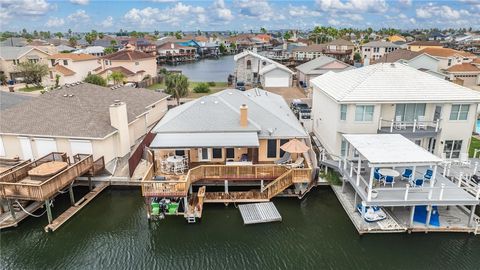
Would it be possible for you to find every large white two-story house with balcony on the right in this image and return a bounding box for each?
[311,63,480,158]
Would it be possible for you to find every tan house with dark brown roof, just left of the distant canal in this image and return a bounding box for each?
[96,49,157,82]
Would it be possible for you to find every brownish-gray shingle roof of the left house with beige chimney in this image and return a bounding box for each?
[0,83,168,138]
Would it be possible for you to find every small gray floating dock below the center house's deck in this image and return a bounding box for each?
[238,202,282,225]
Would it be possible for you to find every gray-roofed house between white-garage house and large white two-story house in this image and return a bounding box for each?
[296,56,354,87]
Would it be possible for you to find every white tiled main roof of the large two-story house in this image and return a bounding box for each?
[311,63,480,103]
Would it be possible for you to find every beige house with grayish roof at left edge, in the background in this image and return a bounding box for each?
[0,47,50,80]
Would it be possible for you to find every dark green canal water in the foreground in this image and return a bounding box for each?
[0,187,480,270]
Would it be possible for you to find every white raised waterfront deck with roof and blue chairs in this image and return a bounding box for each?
[339,134,480,233]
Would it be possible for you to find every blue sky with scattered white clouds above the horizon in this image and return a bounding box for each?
[0,0,480,32]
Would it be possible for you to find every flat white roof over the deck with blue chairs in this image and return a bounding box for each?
[343,134,442,166]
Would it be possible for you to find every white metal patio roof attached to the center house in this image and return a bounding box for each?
[150,132,260,149]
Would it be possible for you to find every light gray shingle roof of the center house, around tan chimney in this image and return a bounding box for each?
[153,88,308,138]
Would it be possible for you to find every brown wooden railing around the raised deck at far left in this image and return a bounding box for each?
[0,153,93,201]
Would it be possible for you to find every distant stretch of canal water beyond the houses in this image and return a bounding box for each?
[163,55,235,82]
